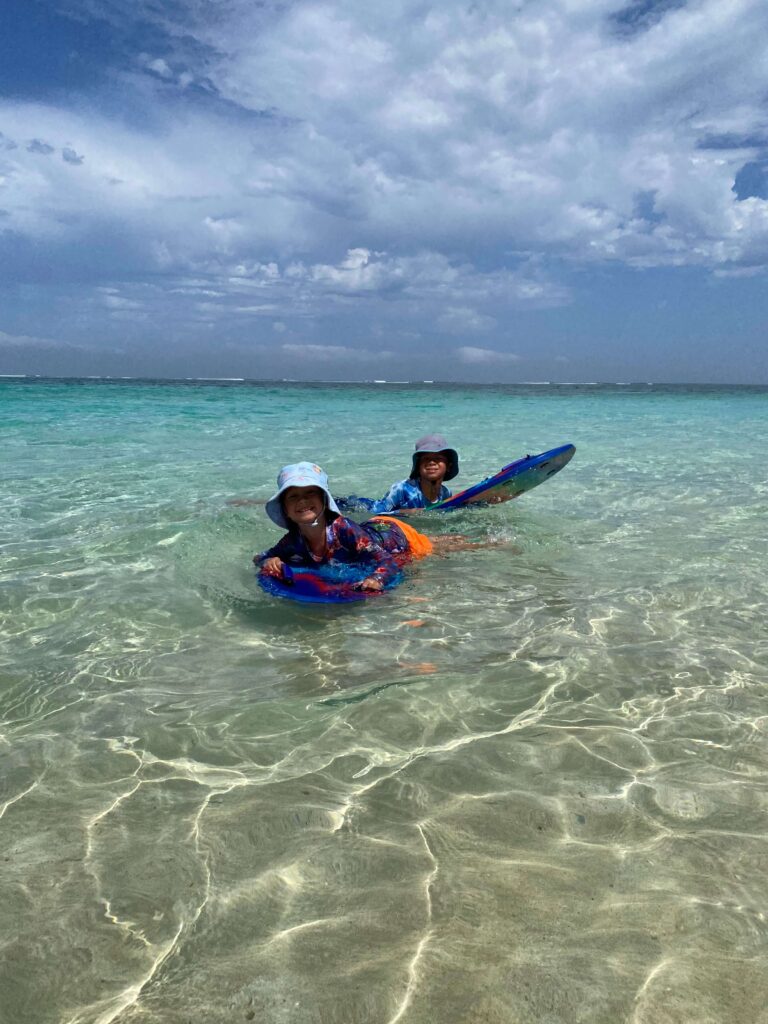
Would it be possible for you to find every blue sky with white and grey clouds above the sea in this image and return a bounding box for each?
[0,0,768,383]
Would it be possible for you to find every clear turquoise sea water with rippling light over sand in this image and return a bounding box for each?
[0,380,768,1024]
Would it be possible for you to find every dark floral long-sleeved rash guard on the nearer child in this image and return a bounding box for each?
[254,515,409,584]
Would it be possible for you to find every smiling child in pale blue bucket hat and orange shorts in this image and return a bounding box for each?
[254,462,432,590]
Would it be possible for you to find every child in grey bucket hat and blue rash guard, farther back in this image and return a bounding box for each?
[337,434,459,515]
